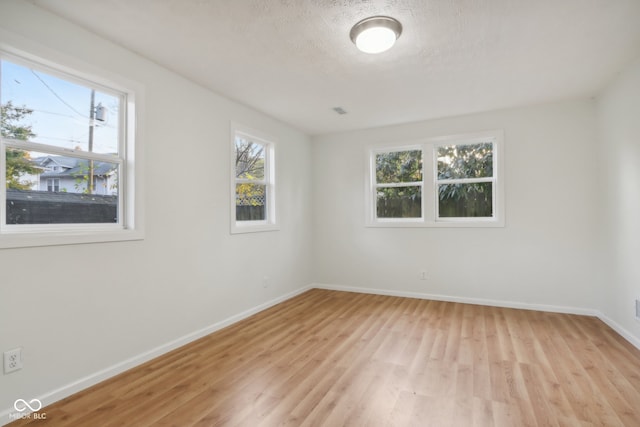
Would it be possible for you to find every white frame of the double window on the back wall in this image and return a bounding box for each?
[365,130,505,227]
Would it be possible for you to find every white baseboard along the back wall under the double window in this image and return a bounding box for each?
[312,283,598,316]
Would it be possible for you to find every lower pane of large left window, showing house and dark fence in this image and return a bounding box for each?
[5,148,119,224]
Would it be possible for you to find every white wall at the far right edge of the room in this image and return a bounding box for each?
[598,56,640,345]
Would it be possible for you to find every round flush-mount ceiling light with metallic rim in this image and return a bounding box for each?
[349,16,402,53]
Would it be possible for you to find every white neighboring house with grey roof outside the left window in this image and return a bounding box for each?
[33,156,118,195]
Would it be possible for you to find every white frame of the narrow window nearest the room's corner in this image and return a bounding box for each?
[230,122,280,234]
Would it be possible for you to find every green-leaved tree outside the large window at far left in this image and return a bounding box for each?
[0,101,39,190]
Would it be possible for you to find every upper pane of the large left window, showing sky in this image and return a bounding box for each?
[0,60,121,155]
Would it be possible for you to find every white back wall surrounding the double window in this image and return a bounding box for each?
[313,100,601,312]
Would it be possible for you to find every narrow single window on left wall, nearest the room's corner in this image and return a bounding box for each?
[231,125,277,233]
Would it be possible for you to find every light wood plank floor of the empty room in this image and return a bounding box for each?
[8,290,640,427]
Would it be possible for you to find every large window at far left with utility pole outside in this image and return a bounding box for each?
[0,47,140,247]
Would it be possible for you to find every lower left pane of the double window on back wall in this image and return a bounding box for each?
[376,186,422,218]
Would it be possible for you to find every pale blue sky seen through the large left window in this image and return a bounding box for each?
[0,60,120,153]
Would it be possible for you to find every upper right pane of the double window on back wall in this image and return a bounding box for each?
[438,142,493,179]
